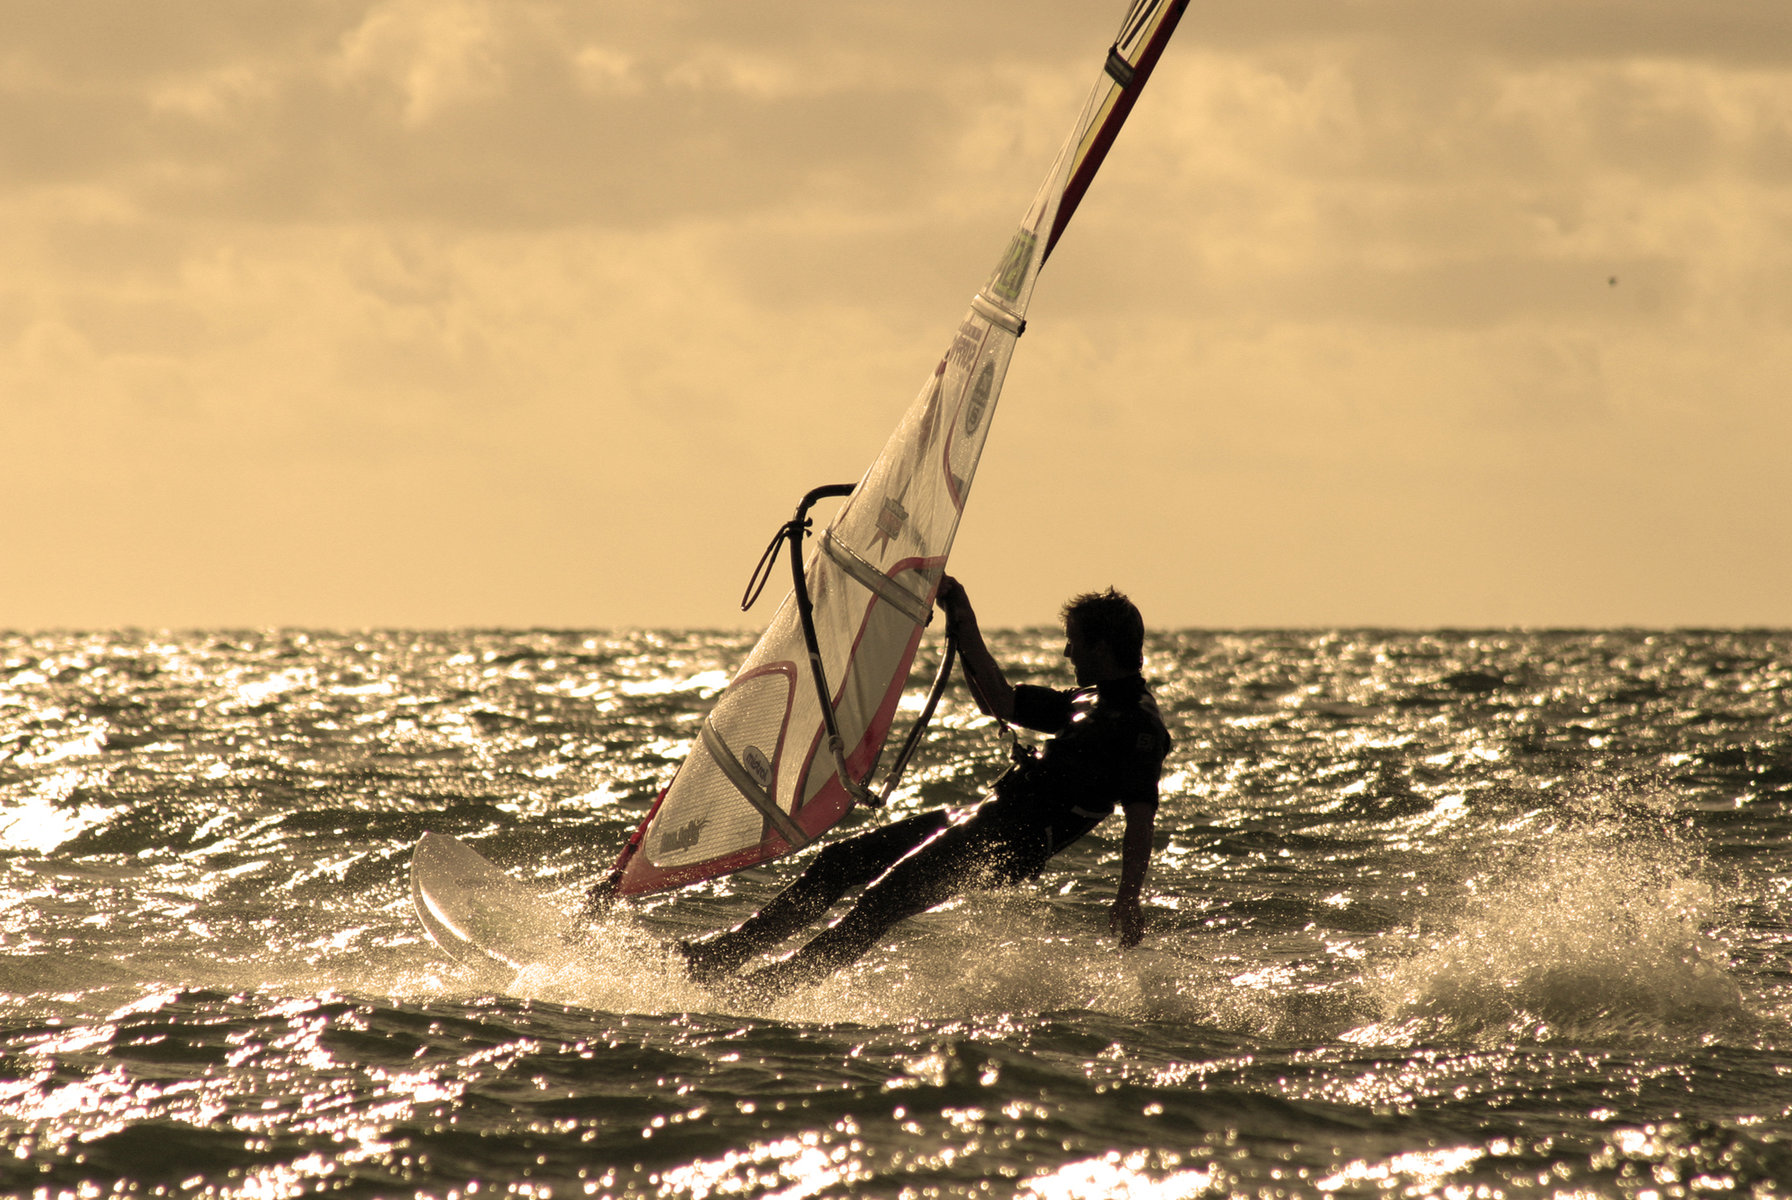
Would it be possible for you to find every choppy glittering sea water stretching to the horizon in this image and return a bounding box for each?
[0,630,1792,1200]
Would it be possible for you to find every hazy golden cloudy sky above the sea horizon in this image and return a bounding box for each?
[0,0,1792,630]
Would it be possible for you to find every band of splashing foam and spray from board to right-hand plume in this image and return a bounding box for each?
[385,813,1758,1044]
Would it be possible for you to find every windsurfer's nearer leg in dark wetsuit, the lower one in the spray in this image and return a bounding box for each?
[742,813,1052,999]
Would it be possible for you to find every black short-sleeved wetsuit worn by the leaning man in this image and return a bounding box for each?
[683,675,1170,996]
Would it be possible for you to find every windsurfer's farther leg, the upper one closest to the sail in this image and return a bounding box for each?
[679,810,946,983]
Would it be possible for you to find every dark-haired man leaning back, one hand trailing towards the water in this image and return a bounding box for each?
[681,575,1170,998]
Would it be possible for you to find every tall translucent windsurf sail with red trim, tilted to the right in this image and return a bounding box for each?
[609,0,1186,896]
